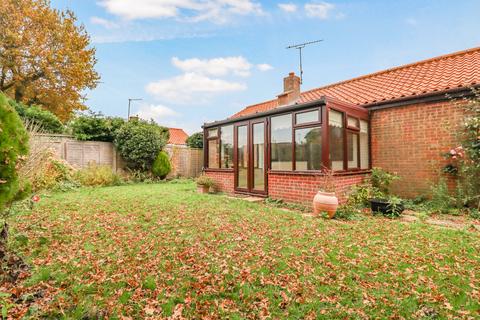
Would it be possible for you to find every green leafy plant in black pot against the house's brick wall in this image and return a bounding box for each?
[370,168,405,217]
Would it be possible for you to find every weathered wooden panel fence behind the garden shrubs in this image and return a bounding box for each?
[34,134,203,178]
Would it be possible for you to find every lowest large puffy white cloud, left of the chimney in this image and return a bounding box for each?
[146,72,247,103]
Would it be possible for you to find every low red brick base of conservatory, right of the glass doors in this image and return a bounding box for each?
[268,172,367,205]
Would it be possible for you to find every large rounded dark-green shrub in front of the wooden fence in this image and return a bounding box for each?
[114,120,169,171]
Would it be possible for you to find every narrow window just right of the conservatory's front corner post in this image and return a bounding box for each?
[328,110,344,171]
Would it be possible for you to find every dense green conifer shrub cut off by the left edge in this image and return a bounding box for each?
[0,93,28,212]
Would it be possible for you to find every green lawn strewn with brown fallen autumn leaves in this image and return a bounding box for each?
[4,182,480,319]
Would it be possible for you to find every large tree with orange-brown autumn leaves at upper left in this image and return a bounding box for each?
[0,0,99,120]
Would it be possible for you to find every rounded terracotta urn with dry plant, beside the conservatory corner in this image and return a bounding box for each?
[313,168,338,219]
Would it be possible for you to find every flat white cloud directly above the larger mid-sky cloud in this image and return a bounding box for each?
[172,56,252,77]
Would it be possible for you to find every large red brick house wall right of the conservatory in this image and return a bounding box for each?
[370,102,464,197]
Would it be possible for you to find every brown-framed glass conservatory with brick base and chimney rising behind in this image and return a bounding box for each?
[203,74,370,202]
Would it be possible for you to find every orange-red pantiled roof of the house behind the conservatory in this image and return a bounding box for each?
[232,47,480,118]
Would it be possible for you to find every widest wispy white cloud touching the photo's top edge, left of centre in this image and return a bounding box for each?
[99,0,263,23]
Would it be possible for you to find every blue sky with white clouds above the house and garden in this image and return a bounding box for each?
[52,0,480,134]
